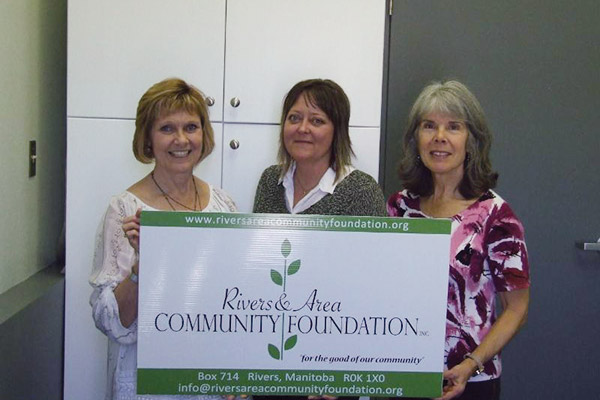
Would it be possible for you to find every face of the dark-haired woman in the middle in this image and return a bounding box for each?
[283,94,335,168]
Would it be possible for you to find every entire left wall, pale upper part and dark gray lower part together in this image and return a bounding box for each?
[0,0,67,400]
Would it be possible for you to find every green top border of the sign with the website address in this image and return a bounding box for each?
[141,211,452,235]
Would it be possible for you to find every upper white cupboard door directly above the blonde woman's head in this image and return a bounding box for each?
[67,0,225,121]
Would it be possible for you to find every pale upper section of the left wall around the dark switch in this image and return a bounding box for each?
[0,0,67,294]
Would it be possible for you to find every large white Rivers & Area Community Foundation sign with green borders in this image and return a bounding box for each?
[138,212,450,397]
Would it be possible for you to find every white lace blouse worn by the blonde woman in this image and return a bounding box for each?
[90,186,236,400]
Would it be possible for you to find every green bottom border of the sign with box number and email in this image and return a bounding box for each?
[137,368,442,398]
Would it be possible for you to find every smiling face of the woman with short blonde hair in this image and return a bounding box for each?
[150,111,202,173]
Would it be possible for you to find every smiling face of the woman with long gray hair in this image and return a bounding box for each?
[417,112,469,180]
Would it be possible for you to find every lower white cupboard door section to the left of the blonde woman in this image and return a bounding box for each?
[65,118,152,400]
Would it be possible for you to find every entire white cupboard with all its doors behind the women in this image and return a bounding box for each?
[65,0,386,399]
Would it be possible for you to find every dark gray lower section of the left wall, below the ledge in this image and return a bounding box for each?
[0,268,65,400]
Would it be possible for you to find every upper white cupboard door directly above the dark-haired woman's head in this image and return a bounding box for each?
[224,0,386,126]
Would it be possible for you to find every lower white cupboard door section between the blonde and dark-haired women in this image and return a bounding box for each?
[223,124,279,212]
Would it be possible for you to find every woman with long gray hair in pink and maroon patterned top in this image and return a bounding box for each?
[387,81,530,400]
